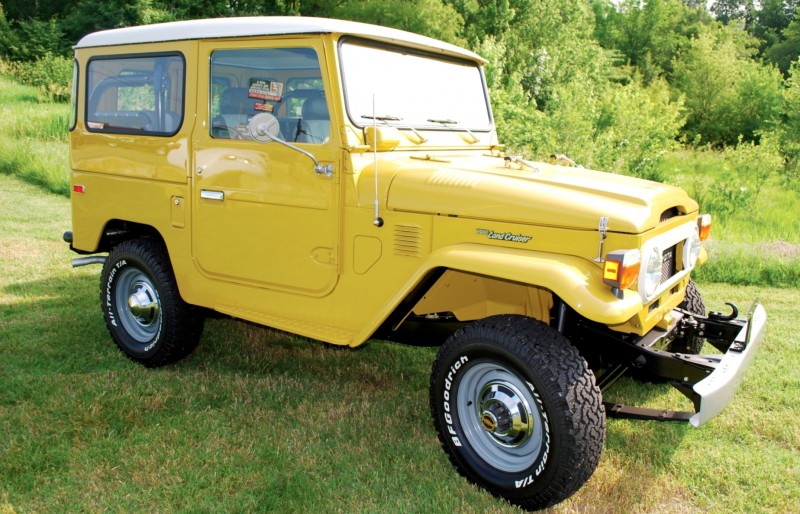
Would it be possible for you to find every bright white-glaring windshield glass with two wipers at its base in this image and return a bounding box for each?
[340,42,491,131]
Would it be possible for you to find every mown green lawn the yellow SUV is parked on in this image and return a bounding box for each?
[0,175,800,513]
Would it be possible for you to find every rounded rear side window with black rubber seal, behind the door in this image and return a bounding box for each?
[86,54,186,136]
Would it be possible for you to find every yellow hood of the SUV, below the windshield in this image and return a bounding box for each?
[373,157,698,234]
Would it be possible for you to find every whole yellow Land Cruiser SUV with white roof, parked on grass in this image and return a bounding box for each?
[64,17,766,508]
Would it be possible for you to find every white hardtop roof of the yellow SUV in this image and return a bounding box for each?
[75,16,486,63]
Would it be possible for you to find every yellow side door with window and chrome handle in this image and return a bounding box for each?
[192,39,340,296]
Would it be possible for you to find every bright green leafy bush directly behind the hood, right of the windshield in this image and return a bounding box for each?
[494,71,683,180]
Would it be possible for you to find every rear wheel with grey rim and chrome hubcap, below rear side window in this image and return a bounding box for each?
[100,239,203,367]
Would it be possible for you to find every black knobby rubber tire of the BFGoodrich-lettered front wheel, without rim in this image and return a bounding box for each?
[430,315,606,509]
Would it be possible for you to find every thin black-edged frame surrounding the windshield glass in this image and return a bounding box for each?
[337,36,494,133]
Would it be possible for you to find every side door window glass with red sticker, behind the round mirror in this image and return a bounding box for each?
[209,48,331,144]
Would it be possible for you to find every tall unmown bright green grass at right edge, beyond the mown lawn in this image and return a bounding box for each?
[660,151,800,288]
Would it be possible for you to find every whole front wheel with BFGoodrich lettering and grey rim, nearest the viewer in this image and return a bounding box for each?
[430,316,605,509]
